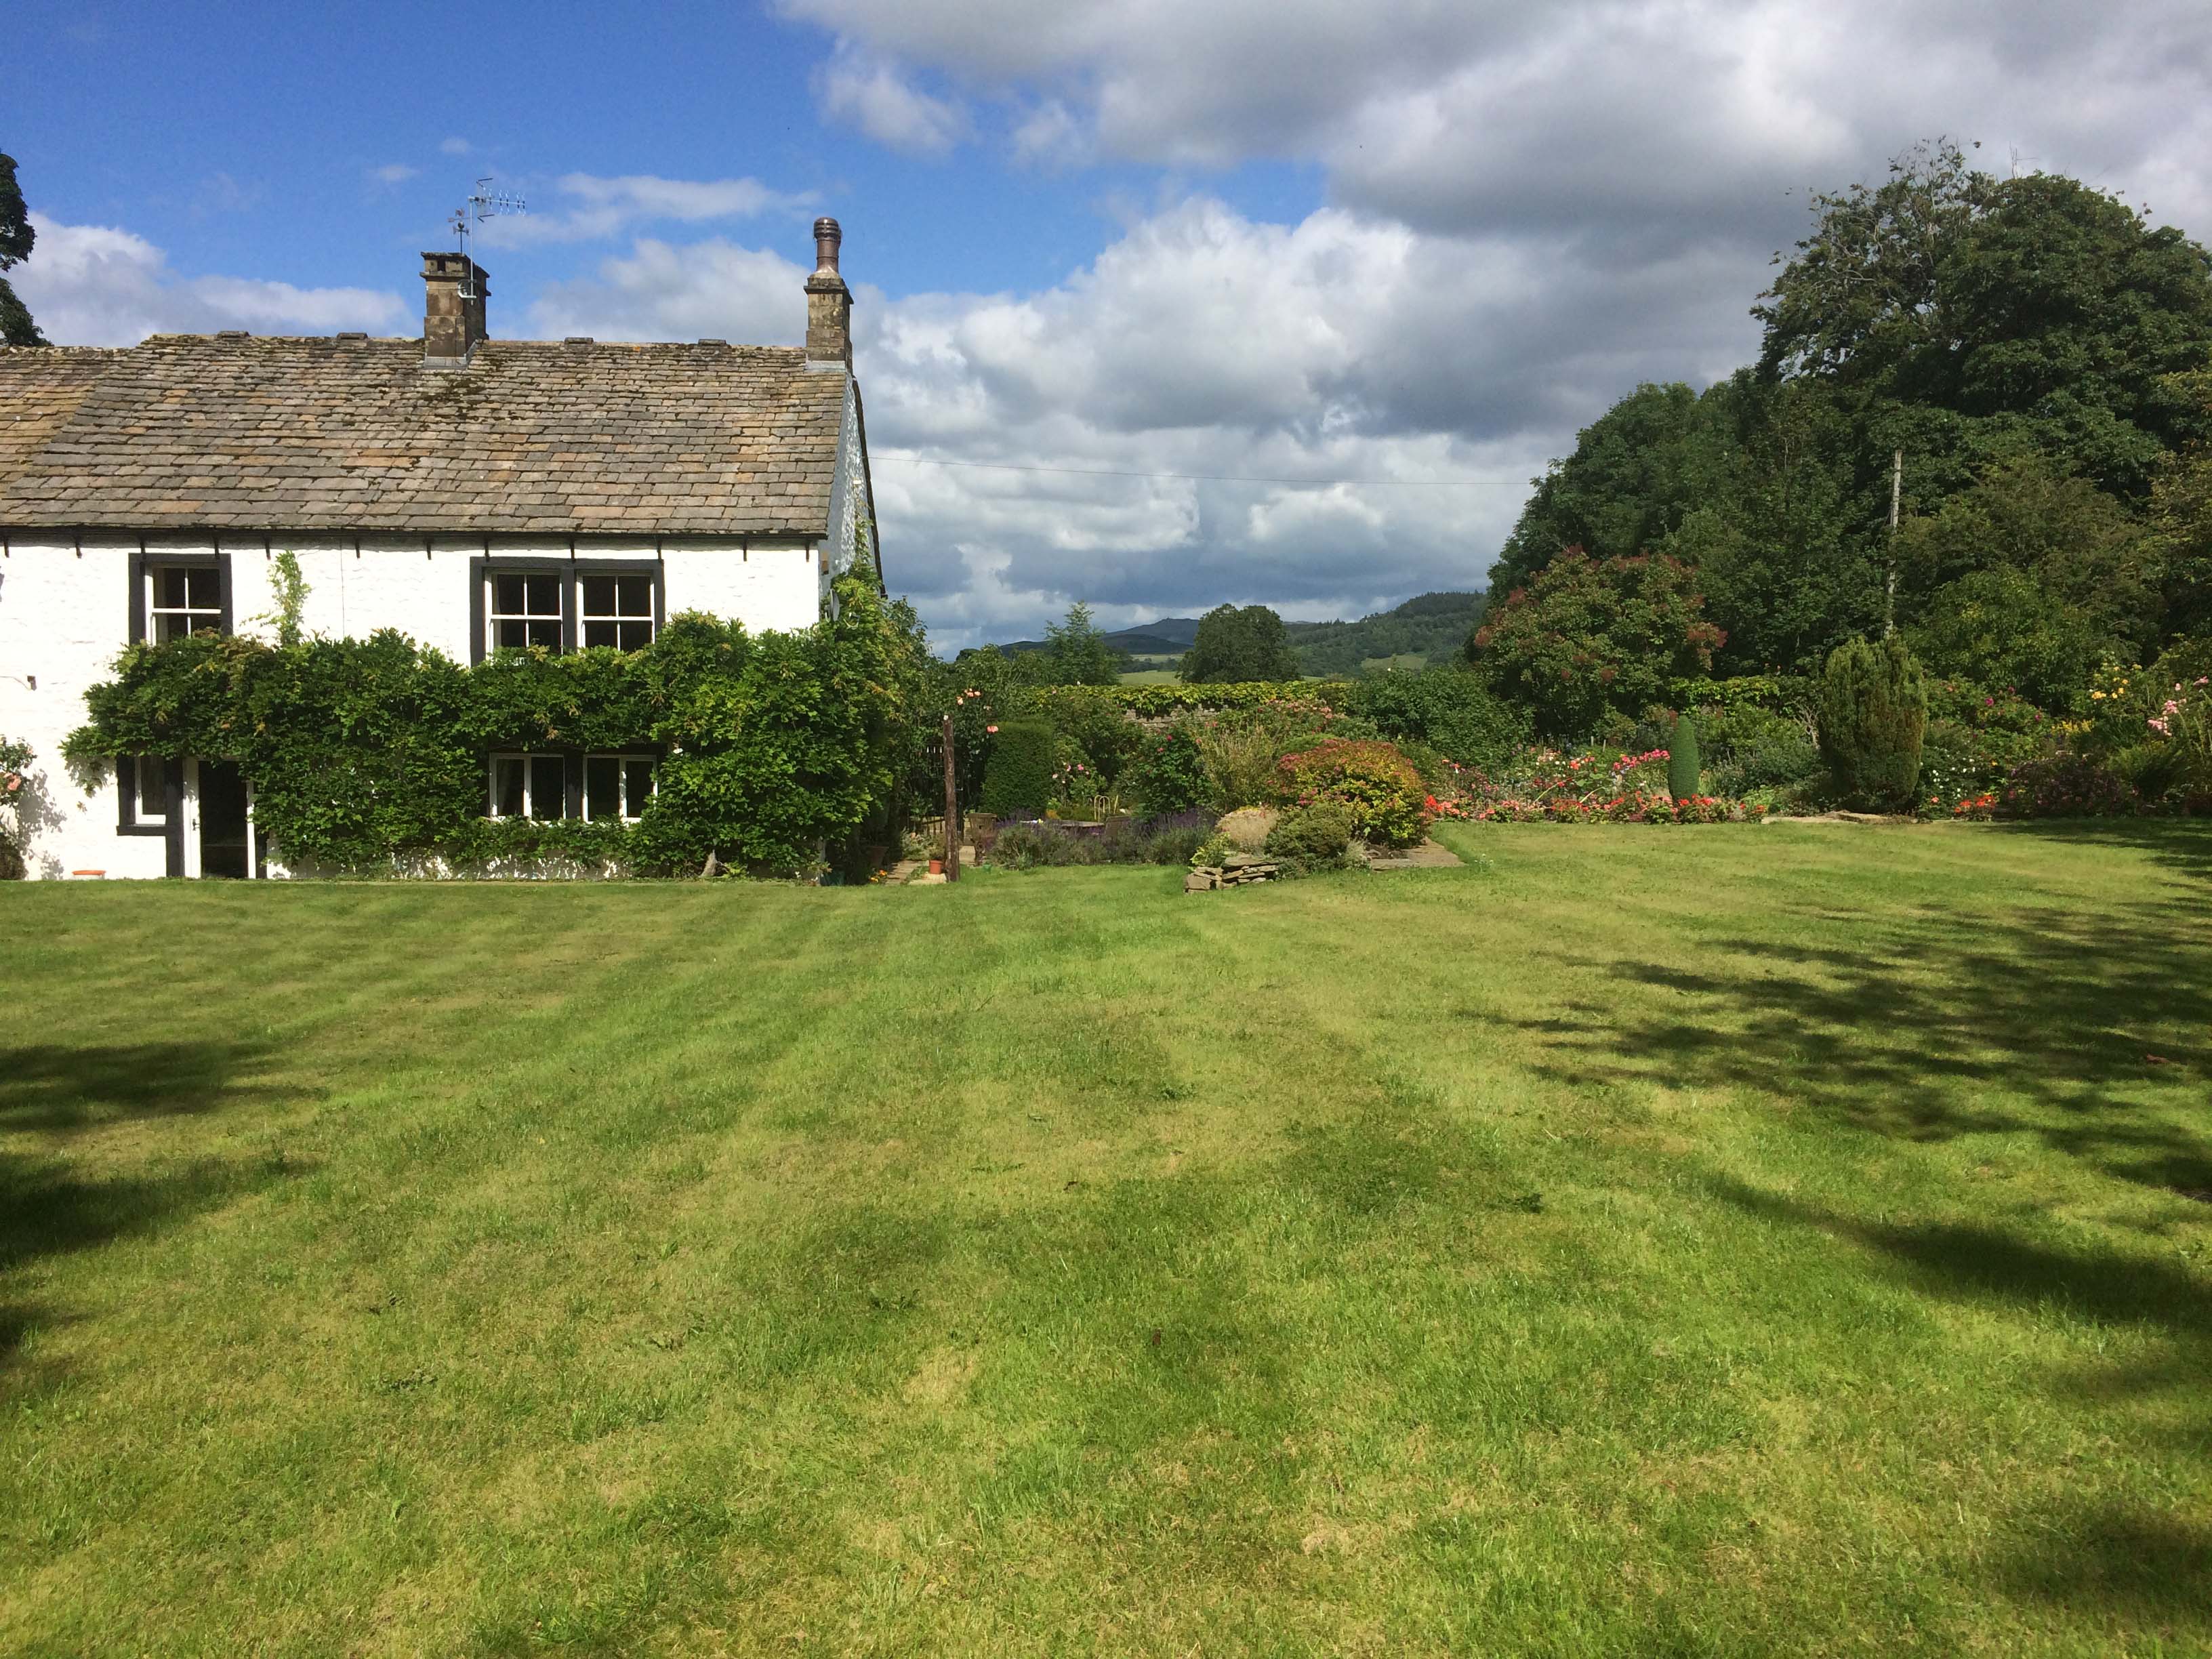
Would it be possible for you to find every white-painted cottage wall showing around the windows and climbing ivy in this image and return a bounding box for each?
[0,535,827,878]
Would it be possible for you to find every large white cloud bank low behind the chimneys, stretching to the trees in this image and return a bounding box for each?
[533,199,1698,646]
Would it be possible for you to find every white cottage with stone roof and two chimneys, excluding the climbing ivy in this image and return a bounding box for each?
[0,219,882,878]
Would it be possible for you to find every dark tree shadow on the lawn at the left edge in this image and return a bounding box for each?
[0,1042,283,1367]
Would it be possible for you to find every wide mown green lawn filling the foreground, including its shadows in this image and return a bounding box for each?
[0,825,2212,1654]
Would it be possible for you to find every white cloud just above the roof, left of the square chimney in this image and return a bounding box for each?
[11,215,413,345]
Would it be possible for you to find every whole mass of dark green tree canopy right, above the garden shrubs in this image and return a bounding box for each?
[1491,144,2212,695]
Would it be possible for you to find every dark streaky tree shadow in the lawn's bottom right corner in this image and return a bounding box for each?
[1706,1176,2212,1635]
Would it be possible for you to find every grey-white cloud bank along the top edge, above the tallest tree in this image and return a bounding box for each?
[781,0,2212,248]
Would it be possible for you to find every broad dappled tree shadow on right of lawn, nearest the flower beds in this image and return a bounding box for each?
[1522,900,2212,1192]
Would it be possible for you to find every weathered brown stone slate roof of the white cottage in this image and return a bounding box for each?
[0,334,845,537]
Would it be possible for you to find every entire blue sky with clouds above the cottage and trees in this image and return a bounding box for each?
[0,0,2212,646]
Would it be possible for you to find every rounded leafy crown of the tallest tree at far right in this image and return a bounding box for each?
[1752,144,2212,500]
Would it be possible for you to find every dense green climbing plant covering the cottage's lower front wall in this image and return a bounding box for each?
[64,577,927,874]
